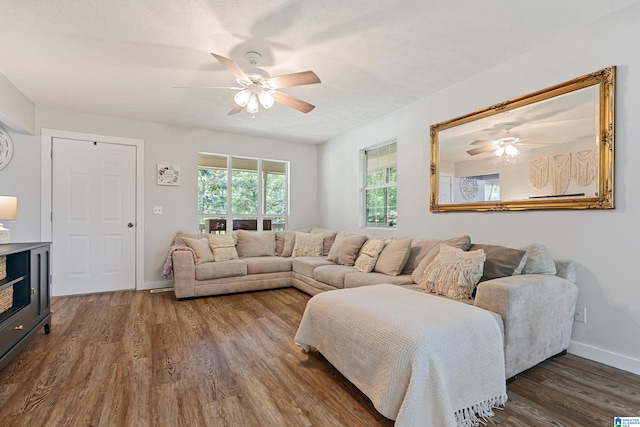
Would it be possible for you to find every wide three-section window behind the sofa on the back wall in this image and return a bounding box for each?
[198,154,289,233]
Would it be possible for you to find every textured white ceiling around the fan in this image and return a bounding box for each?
[0,0,640,143]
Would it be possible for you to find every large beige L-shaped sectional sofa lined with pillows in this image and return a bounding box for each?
[171,227,578,378]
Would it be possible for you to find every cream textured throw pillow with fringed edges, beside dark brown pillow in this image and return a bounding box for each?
[418,244,486,299]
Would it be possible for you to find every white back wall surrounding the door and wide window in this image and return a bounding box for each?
[5,107,318,289]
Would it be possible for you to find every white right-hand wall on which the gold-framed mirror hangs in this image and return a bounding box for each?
[319,5,640,373]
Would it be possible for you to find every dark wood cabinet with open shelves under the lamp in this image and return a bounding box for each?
[0,243,51,369]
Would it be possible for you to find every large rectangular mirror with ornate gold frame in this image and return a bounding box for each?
[430,67,616,212]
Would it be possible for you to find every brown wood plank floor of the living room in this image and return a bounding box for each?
[0,288,640,427]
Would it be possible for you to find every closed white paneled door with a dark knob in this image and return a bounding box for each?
[51,138,136,296]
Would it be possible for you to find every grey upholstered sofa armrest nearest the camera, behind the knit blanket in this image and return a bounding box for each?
[474,274,578,378]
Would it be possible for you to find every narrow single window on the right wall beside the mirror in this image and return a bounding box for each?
[364,142,398,227]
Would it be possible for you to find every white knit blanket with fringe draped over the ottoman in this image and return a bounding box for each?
[295,285,507,427]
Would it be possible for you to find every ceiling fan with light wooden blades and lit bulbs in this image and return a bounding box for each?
[175,51,320,117]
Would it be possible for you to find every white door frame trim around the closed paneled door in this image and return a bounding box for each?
[40,128,144,290]
